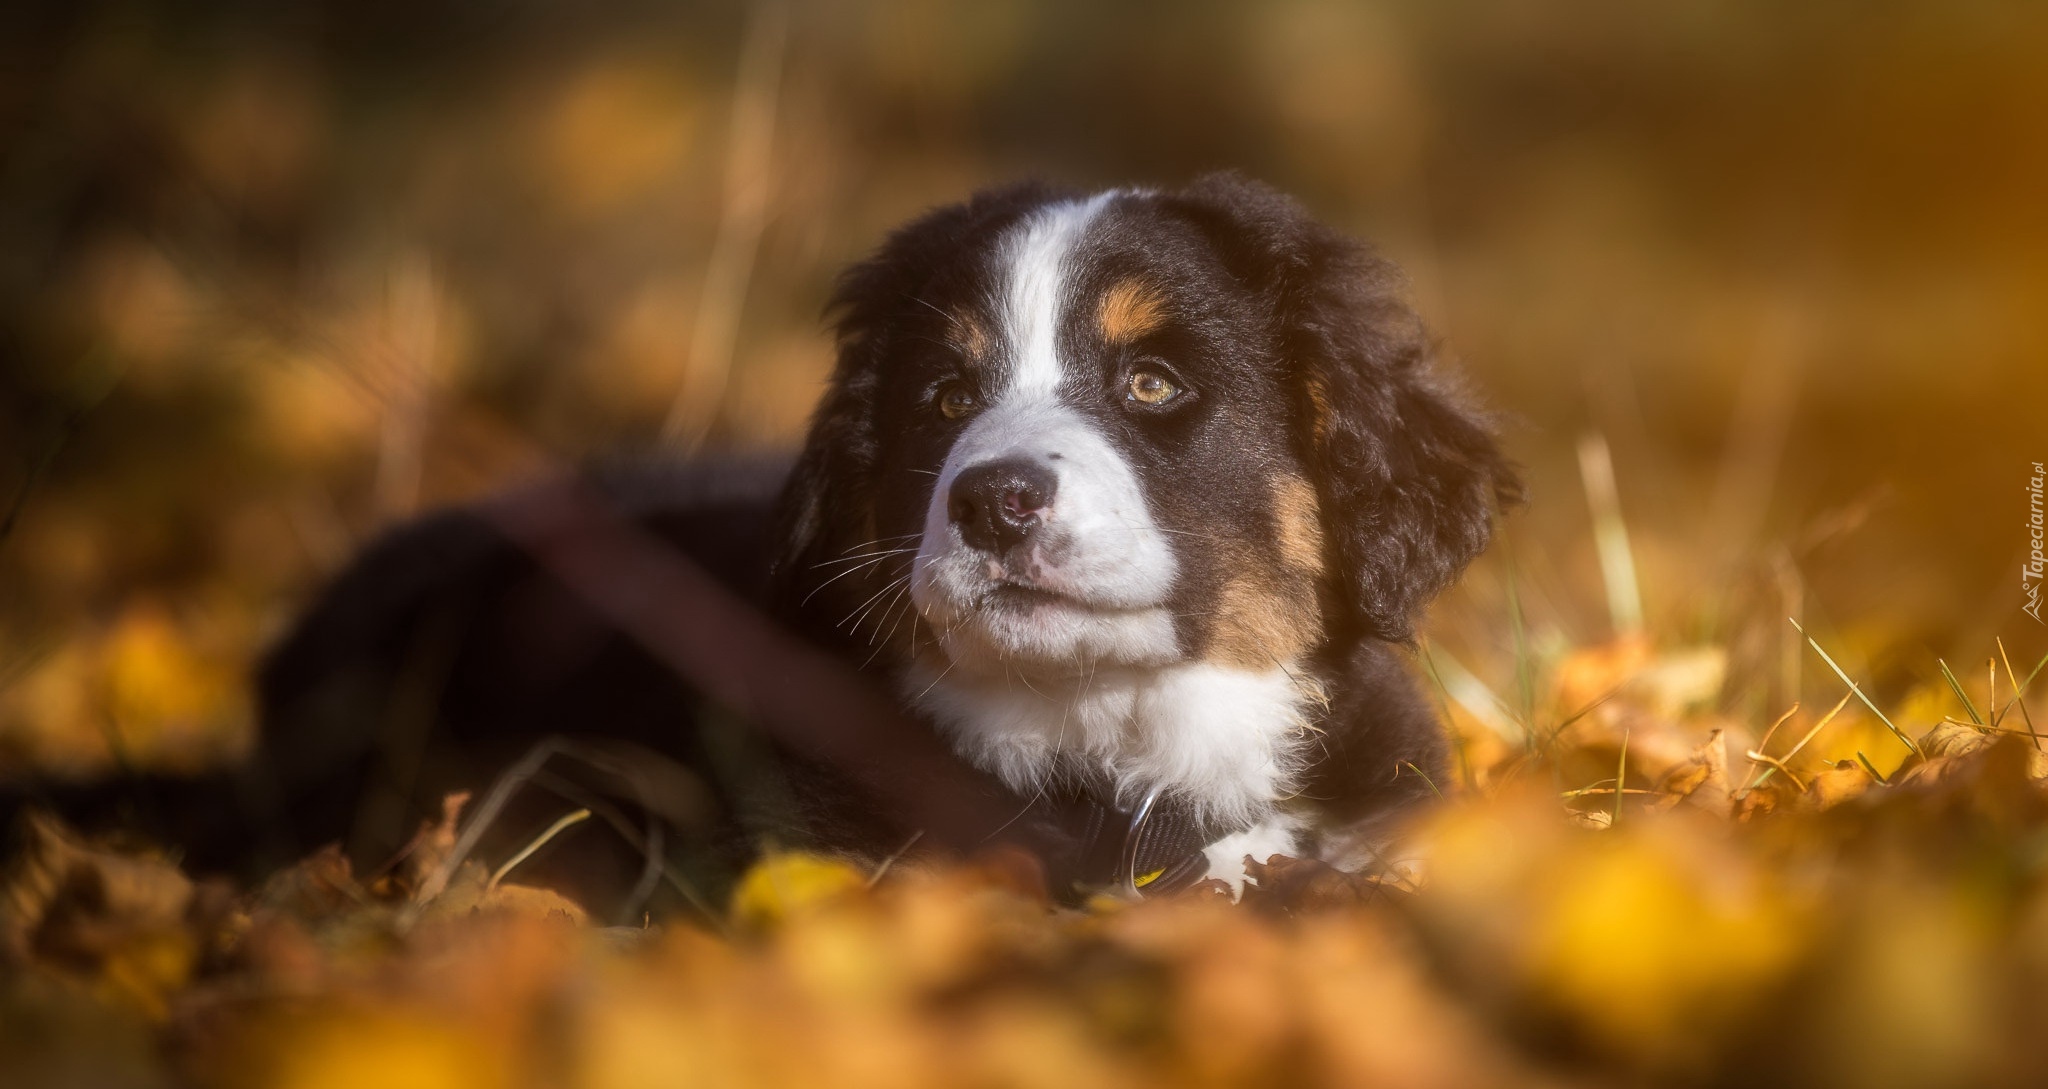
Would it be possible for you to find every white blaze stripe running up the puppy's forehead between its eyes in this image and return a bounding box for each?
[997,190,1116,399]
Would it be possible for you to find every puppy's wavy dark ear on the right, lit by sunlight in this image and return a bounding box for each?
[1171,174,1522,641]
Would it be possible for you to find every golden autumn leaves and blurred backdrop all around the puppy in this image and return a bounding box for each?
[0,0,2048,1087]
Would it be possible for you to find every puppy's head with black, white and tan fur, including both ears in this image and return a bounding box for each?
[778,176,1516,673]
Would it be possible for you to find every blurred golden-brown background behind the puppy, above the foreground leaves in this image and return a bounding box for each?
[0,0,2048,774]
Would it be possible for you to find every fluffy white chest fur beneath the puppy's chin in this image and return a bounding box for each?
[905,663,1313,827]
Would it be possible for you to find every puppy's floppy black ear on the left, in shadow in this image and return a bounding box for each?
[770,182,1055,610]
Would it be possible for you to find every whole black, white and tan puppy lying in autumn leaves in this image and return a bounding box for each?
[19,174,1520,919]
